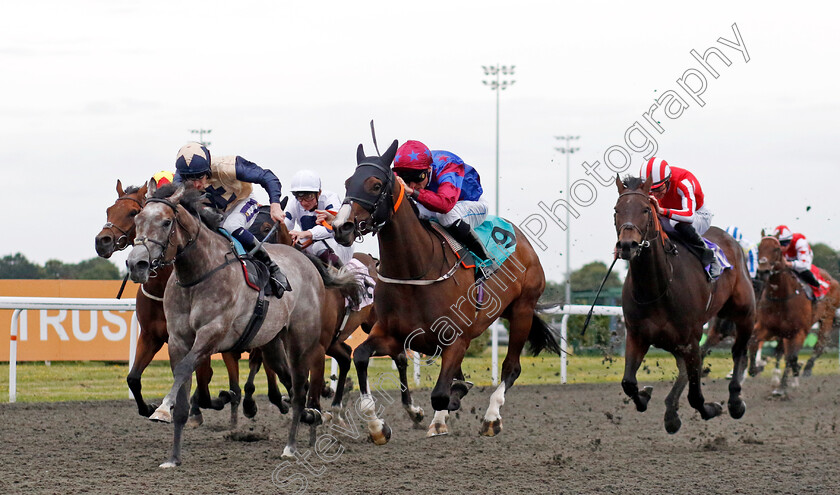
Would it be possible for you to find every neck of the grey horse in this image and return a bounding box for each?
[175,211,228,283]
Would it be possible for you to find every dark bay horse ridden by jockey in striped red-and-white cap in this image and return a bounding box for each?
[614,177,755,433]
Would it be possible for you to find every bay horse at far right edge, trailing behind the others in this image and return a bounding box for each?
[749,236,840,395]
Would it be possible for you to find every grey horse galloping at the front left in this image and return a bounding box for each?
[126,184,358,468]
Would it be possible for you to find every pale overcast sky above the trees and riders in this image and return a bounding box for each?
[0,0,840,281]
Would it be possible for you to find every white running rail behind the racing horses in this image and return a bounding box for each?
[0,297,840,402]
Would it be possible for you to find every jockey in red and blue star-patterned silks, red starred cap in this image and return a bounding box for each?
[394,141,494,274]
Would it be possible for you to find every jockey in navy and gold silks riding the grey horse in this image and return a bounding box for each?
[175,143,291,297]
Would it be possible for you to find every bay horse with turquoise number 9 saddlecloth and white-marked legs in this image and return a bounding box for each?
[333,140,560,445]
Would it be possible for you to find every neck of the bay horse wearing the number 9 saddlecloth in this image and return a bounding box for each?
[378,200,445,279]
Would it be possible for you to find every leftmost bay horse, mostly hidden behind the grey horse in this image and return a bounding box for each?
[95,179,264,426]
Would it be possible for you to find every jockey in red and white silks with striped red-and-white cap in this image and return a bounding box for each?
[640,156,715,267]
